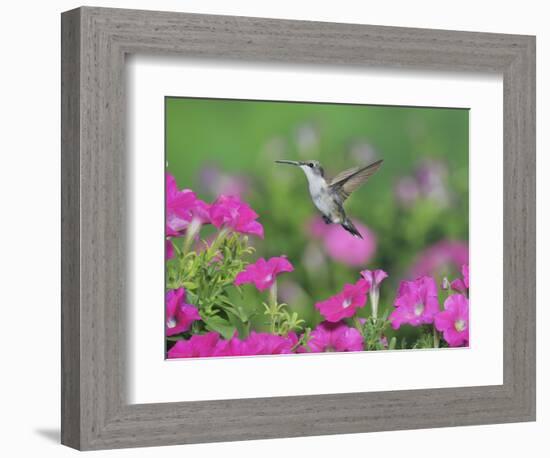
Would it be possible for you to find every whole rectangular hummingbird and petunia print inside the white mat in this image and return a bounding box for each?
[164,97,470,359]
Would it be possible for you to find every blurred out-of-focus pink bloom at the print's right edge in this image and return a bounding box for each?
[411,240,469,278]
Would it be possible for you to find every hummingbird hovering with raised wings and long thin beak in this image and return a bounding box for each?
[275,159,383,239]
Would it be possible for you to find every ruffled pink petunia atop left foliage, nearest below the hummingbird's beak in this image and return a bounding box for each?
[210,194,264,238]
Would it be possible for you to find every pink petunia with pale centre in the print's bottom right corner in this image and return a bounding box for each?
[435,294,470,347]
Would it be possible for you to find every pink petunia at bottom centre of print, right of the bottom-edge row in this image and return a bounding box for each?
[308,321,363,353]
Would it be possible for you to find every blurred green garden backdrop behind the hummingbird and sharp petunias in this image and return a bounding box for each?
[166,97,469,340]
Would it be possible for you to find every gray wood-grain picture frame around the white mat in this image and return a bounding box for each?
[61,7,535,450]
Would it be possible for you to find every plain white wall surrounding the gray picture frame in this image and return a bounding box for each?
[0,0,550,458]
